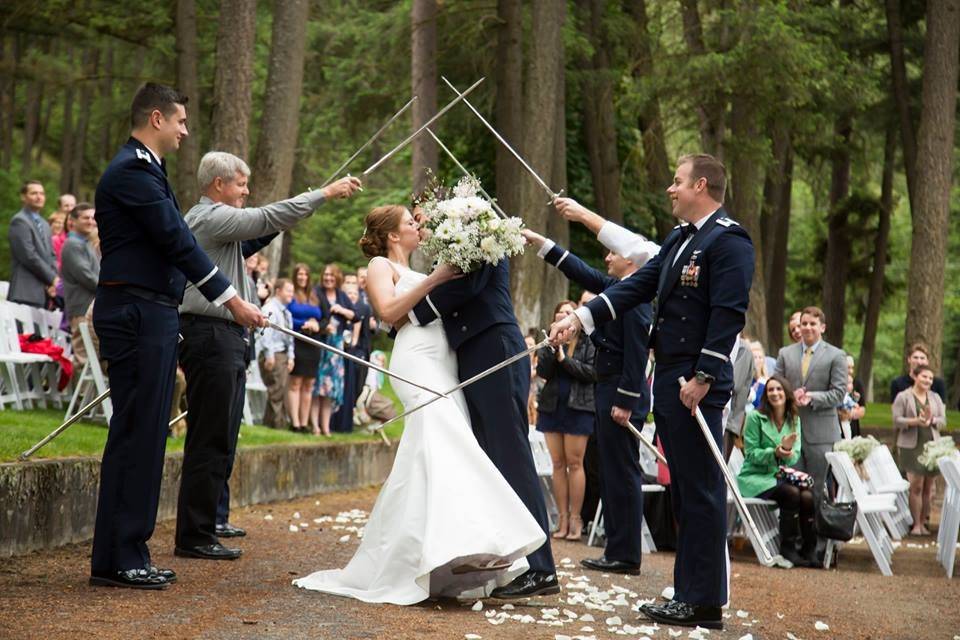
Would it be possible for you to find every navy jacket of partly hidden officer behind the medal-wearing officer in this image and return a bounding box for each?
[541,240,653,422]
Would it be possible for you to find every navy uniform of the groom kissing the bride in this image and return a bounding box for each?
[412,260,555,574]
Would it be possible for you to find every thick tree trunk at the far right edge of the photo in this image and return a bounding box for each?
[904,0,960,371]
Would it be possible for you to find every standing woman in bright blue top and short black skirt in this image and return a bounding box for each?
[287,262,330,433]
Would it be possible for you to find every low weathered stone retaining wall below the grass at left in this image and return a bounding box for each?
[0,442,396,557]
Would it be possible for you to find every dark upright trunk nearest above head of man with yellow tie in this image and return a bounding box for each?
[823,112,853,348]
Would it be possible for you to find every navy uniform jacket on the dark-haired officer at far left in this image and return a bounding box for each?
[96,138,236,306]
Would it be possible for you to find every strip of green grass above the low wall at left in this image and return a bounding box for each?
[0,384,403,462]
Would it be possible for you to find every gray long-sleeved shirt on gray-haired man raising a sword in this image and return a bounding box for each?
[180,189,324,320]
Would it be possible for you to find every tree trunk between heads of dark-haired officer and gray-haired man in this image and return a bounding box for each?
[175,0,201,205]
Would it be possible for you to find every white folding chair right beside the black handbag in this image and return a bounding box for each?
[824,451,897,576]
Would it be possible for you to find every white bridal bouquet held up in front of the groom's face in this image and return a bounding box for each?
[420,176,524,273]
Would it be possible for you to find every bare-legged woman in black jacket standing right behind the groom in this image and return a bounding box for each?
[528,300,597,540]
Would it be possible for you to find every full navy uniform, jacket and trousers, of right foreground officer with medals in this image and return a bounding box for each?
[587,208,754,606]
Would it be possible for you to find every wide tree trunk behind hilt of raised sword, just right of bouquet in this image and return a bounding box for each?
[511,0,566,329]
